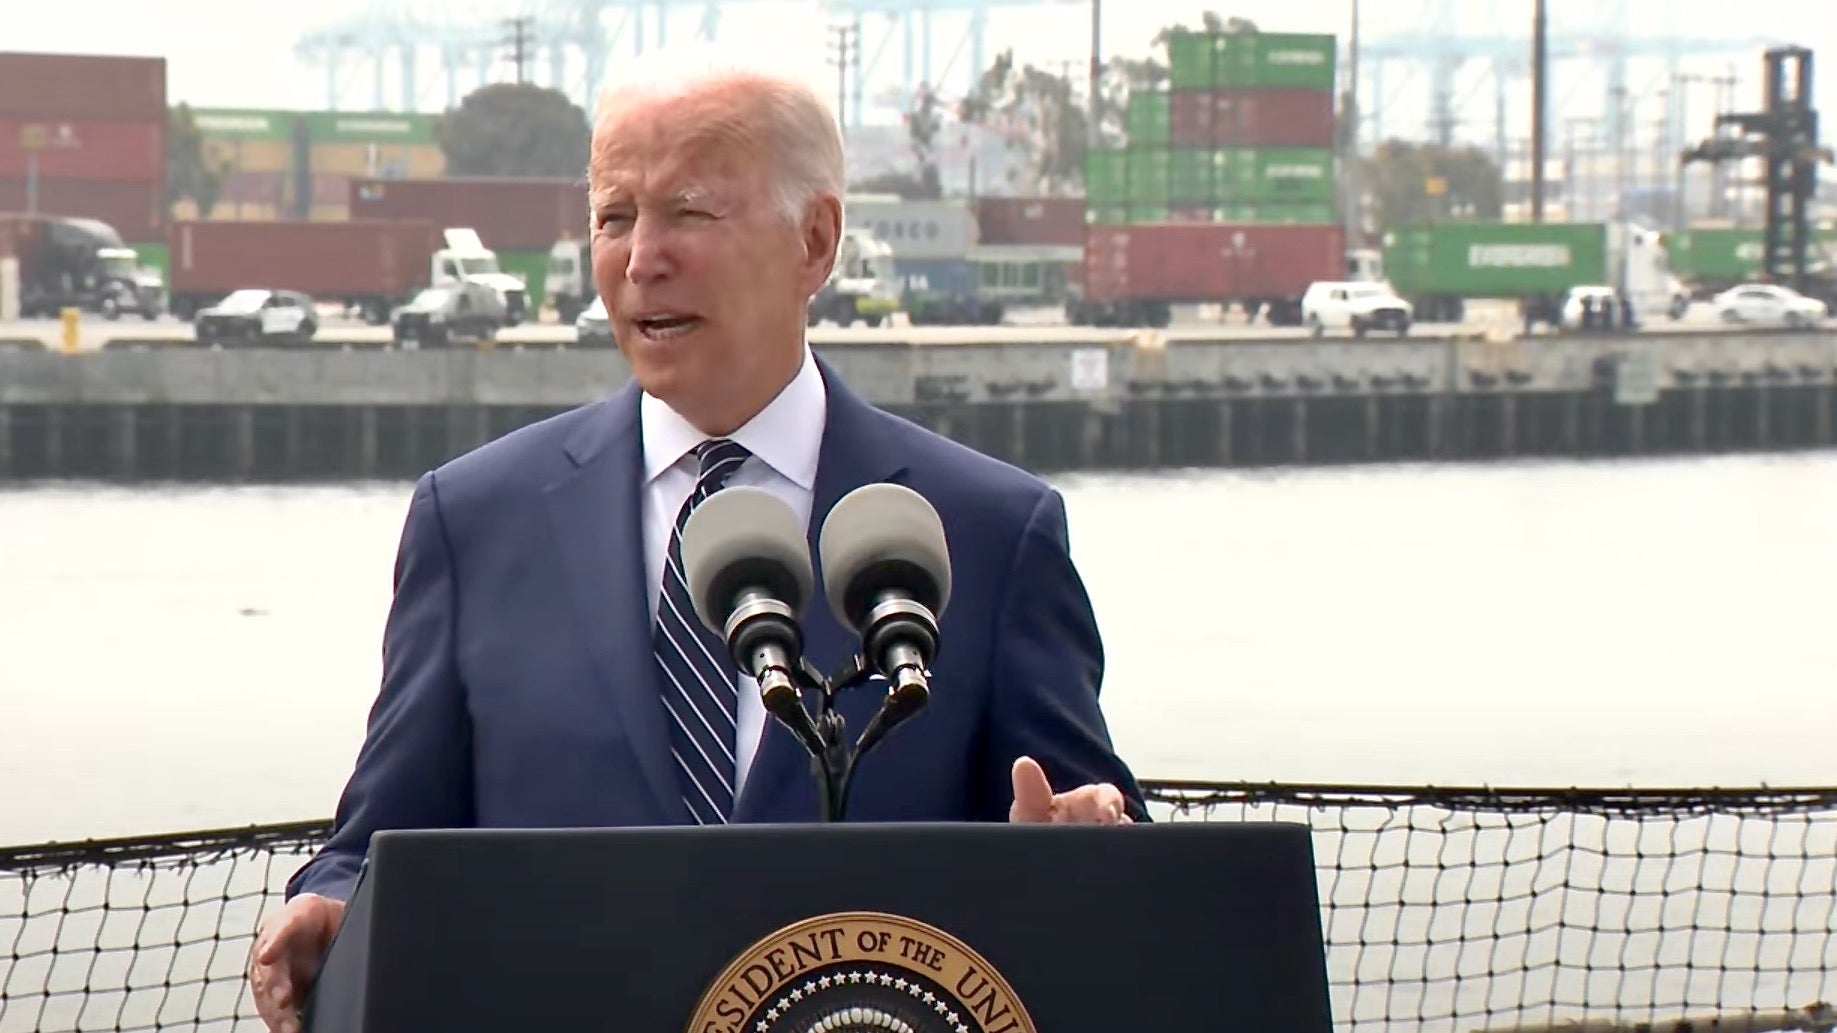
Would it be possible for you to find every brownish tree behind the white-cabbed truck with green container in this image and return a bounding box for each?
[1347,140,1505,232]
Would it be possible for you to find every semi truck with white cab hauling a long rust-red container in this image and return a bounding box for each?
[167,219,527,325]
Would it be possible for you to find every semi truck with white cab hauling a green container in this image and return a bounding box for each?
[1381,222,1690,325]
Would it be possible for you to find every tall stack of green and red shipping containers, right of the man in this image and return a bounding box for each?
[1071,33,1345,325]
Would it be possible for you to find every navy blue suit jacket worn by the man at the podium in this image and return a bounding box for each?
[287,362,1146,899]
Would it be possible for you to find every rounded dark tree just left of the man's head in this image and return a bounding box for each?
[435,83,590,176]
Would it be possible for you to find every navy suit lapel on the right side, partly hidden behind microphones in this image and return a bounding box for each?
[733,358,904,822]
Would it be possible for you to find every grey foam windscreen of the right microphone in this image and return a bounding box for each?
[817,483,950,629]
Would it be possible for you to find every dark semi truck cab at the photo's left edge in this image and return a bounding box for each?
[0,213,163,320]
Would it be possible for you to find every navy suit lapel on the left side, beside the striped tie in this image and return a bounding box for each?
[547,382,689,823]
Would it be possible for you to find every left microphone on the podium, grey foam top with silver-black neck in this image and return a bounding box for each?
[682,487,823,754]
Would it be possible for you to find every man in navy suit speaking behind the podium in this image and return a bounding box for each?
[250,42,1146,1033]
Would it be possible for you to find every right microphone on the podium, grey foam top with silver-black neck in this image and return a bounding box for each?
[817,483,950,720]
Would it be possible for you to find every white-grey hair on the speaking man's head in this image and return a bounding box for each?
[593,42,847,226]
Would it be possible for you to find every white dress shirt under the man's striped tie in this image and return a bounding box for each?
[637,346,828,800]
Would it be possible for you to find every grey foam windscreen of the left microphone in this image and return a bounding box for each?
[682,487,814,634]
